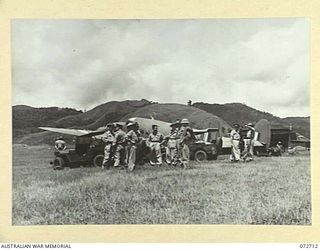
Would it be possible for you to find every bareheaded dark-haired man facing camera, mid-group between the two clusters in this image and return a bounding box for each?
[148,125,163,166]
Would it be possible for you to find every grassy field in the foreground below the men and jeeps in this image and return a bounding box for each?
[12,145,311,225]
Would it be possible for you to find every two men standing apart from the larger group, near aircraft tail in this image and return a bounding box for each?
[230,123,255,162]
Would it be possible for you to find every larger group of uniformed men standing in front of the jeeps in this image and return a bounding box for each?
[102,119,193,171]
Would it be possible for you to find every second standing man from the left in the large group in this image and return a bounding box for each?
[114,123,127,167]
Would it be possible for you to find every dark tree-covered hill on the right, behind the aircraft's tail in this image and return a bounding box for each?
[193,102,310,138]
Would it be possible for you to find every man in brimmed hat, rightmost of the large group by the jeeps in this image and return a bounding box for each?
[178,119,194,168]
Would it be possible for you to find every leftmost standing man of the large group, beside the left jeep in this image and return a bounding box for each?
[102,123,116,169]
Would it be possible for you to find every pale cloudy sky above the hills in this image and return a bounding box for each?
[11,18,310,117]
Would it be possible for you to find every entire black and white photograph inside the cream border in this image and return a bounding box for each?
[10,17,312,226]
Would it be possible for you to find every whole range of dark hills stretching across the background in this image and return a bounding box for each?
[12,99,310,145]
